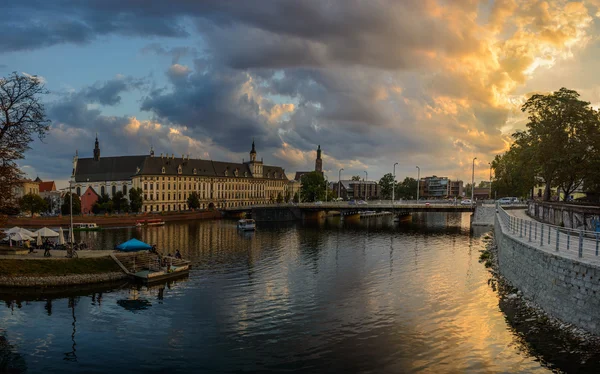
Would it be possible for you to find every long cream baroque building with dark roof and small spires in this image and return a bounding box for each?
[73,137,288,212]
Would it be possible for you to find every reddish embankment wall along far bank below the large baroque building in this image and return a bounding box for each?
[3,210,221,227]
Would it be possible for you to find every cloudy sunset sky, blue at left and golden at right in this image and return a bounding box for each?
[0,0,600,187]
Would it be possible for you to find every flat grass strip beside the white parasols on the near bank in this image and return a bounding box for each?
[0,258,121,277]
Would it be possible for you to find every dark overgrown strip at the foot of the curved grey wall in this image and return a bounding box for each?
[480,235,600,372]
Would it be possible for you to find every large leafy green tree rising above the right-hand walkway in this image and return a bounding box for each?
[509,88,600,200]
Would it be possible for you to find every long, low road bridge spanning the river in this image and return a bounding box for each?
[223,201,473,221]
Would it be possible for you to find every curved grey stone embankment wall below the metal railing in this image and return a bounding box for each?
[495,216,600,335]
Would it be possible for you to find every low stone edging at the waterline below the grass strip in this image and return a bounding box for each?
[0,271,127,287]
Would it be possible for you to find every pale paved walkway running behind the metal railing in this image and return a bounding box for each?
[500,209,600,266]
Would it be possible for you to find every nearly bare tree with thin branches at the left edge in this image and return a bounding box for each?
[0,72,50,211]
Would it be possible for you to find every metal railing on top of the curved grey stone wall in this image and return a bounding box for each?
[496,205,600,260]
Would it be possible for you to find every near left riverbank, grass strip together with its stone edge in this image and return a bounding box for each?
[0,257,127,287]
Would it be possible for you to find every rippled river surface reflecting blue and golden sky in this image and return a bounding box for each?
[0,213,548,373]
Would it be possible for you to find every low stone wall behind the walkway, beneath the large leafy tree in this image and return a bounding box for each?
[527,201,600,231]
